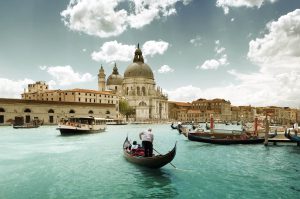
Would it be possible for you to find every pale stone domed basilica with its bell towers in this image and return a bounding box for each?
[98,45,168,121]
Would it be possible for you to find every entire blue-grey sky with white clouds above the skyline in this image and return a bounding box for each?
[0,0,300,108]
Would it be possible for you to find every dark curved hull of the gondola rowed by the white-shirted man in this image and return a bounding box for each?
[123,137,176,169]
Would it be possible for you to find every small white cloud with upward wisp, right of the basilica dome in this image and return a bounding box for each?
[196,40,229,70]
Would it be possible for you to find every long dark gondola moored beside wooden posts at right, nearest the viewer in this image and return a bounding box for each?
[188,133,265,145]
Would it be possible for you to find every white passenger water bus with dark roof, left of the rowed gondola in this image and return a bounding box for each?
[57,117,106,135]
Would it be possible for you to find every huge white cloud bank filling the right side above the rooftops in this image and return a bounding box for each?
[166,9,300,107]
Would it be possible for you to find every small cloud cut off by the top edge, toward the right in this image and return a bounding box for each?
[216,0,277,14]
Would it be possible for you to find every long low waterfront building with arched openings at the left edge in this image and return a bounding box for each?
[0,98,118,125]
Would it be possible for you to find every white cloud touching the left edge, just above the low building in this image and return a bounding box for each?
[0,78,34,98]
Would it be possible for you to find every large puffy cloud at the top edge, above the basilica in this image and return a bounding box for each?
[61,0,191,38]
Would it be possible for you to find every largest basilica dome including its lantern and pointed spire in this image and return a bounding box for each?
[124,45,154,79]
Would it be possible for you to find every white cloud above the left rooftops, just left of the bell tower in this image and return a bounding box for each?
[47,65,94,86]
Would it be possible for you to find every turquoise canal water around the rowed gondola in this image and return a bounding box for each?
[0,124,300,199]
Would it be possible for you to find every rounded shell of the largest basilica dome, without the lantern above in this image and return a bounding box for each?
[124,62,154,79]
